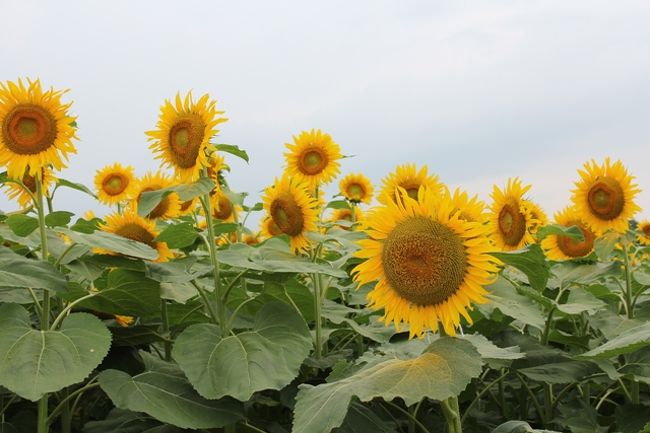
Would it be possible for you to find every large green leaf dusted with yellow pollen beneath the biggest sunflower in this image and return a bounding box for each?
[293,337,482,433]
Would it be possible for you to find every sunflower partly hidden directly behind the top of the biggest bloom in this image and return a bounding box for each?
[377,164,442,205]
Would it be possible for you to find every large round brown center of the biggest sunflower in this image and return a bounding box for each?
[382,217,467,305]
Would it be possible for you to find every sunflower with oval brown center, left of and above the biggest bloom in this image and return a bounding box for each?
[262,176,318,252]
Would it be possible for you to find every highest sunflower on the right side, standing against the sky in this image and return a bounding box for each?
[571,158,641,235]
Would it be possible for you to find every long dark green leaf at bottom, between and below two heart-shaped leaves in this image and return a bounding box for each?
[99,352,242,429]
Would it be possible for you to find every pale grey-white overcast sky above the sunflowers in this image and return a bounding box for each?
[0,0,650,221]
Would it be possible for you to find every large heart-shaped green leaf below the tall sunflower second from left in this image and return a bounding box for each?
[173,301,312,401]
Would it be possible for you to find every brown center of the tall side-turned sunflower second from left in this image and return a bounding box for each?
[169,115,205,168]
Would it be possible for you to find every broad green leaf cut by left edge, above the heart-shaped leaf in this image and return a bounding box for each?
[0,247,68,291]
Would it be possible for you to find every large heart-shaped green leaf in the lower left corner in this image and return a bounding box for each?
[0,304,111,401]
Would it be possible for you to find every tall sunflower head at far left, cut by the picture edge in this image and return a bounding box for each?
[0,79,77,179]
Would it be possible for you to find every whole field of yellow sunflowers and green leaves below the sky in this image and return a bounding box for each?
[0,79,650,433]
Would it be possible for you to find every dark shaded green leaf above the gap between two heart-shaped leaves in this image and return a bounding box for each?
[72,268,160,316]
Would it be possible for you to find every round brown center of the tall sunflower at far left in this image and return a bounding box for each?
[2,104,57,155]
